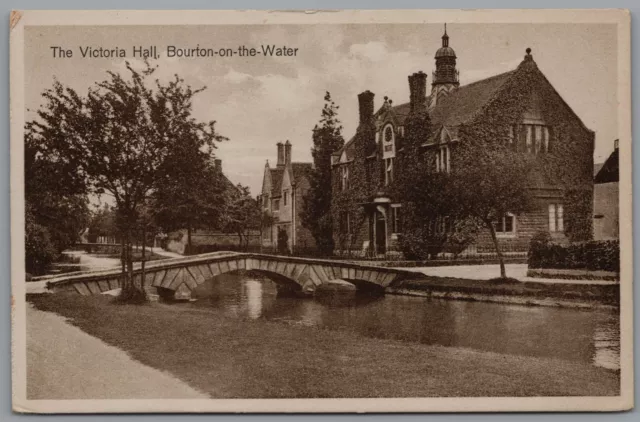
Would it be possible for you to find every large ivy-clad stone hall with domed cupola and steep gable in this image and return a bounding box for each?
[332,28,595,254]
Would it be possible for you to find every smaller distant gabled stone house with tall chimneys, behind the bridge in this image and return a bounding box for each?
[260,141,315,253]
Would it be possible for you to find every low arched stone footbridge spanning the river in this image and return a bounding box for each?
[47,252,417,299]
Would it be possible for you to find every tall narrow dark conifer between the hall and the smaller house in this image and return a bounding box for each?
[301,92,344,255]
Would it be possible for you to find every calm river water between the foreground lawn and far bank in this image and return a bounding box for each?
[187,275,620,369]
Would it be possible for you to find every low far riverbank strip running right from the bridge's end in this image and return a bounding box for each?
[386,276,620,308]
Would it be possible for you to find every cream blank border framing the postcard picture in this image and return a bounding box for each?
[10,9,633,413]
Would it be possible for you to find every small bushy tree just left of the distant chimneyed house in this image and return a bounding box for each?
[224,184,266,250]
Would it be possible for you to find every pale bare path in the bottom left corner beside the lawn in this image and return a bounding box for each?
[27,304,210,400]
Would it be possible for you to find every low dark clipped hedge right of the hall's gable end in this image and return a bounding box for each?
[528,233,620,272]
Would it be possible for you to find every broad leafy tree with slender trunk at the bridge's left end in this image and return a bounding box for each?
[30,62,224,301]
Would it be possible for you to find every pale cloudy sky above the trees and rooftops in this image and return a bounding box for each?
[25,23,618,195]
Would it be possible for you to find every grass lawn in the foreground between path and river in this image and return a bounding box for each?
[27,293,620,398]
